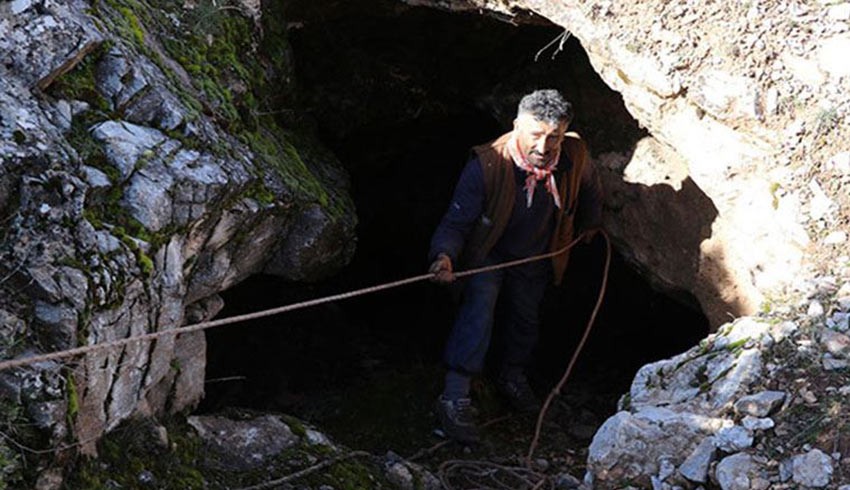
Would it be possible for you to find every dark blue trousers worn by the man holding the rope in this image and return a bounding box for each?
[444,260,552,374]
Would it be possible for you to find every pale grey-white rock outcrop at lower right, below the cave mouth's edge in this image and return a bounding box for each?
[588,319,771,488]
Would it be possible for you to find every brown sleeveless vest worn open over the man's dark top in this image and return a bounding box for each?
[463,132,587,284]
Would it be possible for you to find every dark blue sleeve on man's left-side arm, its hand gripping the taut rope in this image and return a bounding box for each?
[428,157,484,263]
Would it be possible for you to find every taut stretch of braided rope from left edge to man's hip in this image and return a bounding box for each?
[0,234,584,371]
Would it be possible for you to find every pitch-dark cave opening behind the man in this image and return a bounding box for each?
[201,0,709,451]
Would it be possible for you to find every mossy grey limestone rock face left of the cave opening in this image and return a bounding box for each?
[0,0,355,462]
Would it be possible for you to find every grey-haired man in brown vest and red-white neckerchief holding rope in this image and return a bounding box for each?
[429,90,601,443]
